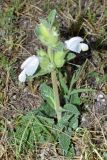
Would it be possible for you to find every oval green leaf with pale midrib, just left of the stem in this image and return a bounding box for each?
[40,83,55,108]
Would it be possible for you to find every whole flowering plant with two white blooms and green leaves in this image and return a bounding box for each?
[19,10,88,154]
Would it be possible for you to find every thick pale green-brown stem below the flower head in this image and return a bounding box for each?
[51,70,61,121]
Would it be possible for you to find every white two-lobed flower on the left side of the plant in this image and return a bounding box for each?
[18,55,39,82]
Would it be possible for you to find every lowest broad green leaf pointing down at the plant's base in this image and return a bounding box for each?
[59,133,70,154]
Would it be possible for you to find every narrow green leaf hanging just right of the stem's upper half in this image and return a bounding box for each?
[59,72,68,94]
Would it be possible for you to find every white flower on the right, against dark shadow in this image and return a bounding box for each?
[65,37,89,53]
